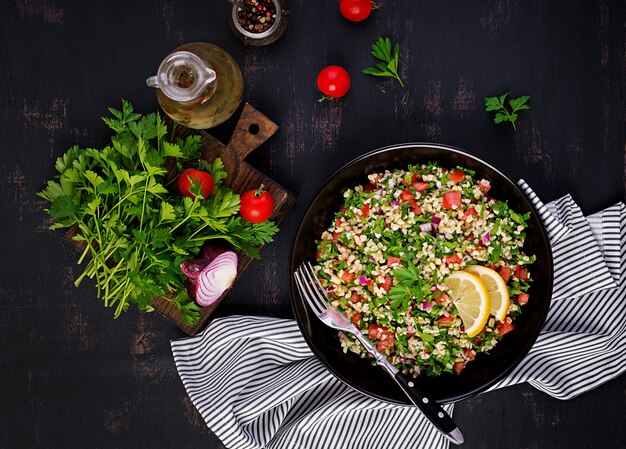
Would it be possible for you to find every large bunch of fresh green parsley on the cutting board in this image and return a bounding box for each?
[39,100,278,325]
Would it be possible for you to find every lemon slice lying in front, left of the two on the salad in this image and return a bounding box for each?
[443,271,491,337]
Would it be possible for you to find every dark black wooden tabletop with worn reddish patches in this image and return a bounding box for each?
[0,0,626,449]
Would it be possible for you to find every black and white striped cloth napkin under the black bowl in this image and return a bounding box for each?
[172,181,626,449]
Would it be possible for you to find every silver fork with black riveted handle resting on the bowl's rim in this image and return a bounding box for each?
[294,262,464,444]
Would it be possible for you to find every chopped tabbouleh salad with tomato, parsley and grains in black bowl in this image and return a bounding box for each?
[315,163,535,376]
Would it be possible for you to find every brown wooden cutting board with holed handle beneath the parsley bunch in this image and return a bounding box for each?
[153,103,296,335]
